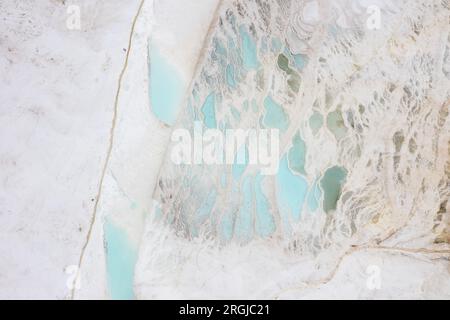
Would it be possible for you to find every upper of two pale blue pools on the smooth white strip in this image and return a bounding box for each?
[149,45,184,125]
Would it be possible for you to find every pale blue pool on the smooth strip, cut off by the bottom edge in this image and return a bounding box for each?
[103,220,137,300]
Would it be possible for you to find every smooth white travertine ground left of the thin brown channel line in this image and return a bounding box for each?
[0,0,141,299]
